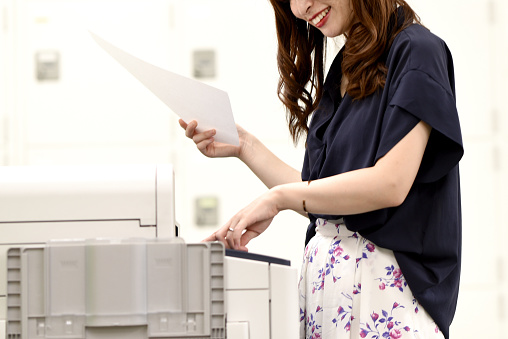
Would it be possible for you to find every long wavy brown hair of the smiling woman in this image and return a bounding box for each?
[270,0,420,143]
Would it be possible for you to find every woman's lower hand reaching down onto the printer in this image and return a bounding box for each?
[203,189,280,251]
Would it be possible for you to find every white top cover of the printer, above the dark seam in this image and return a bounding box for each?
[0,165,175,236]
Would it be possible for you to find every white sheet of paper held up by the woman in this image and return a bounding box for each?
[90,32,239,146]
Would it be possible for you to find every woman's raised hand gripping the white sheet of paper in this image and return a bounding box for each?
[178,119,247,158]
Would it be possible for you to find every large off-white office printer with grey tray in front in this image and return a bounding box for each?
[0,165,299,339]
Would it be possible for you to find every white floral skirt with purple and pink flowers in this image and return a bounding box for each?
[299,219,444,339]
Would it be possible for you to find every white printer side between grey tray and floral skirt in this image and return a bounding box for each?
[225,257,300,339]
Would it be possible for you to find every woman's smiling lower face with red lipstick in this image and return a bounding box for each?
[291,0,353,38]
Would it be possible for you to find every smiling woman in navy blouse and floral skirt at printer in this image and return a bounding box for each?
[180,0,463,339]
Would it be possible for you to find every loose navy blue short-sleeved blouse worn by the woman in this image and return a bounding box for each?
[302,24,463,338]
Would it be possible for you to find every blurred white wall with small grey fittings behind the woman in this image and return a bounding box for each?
[0,0,508,338]
